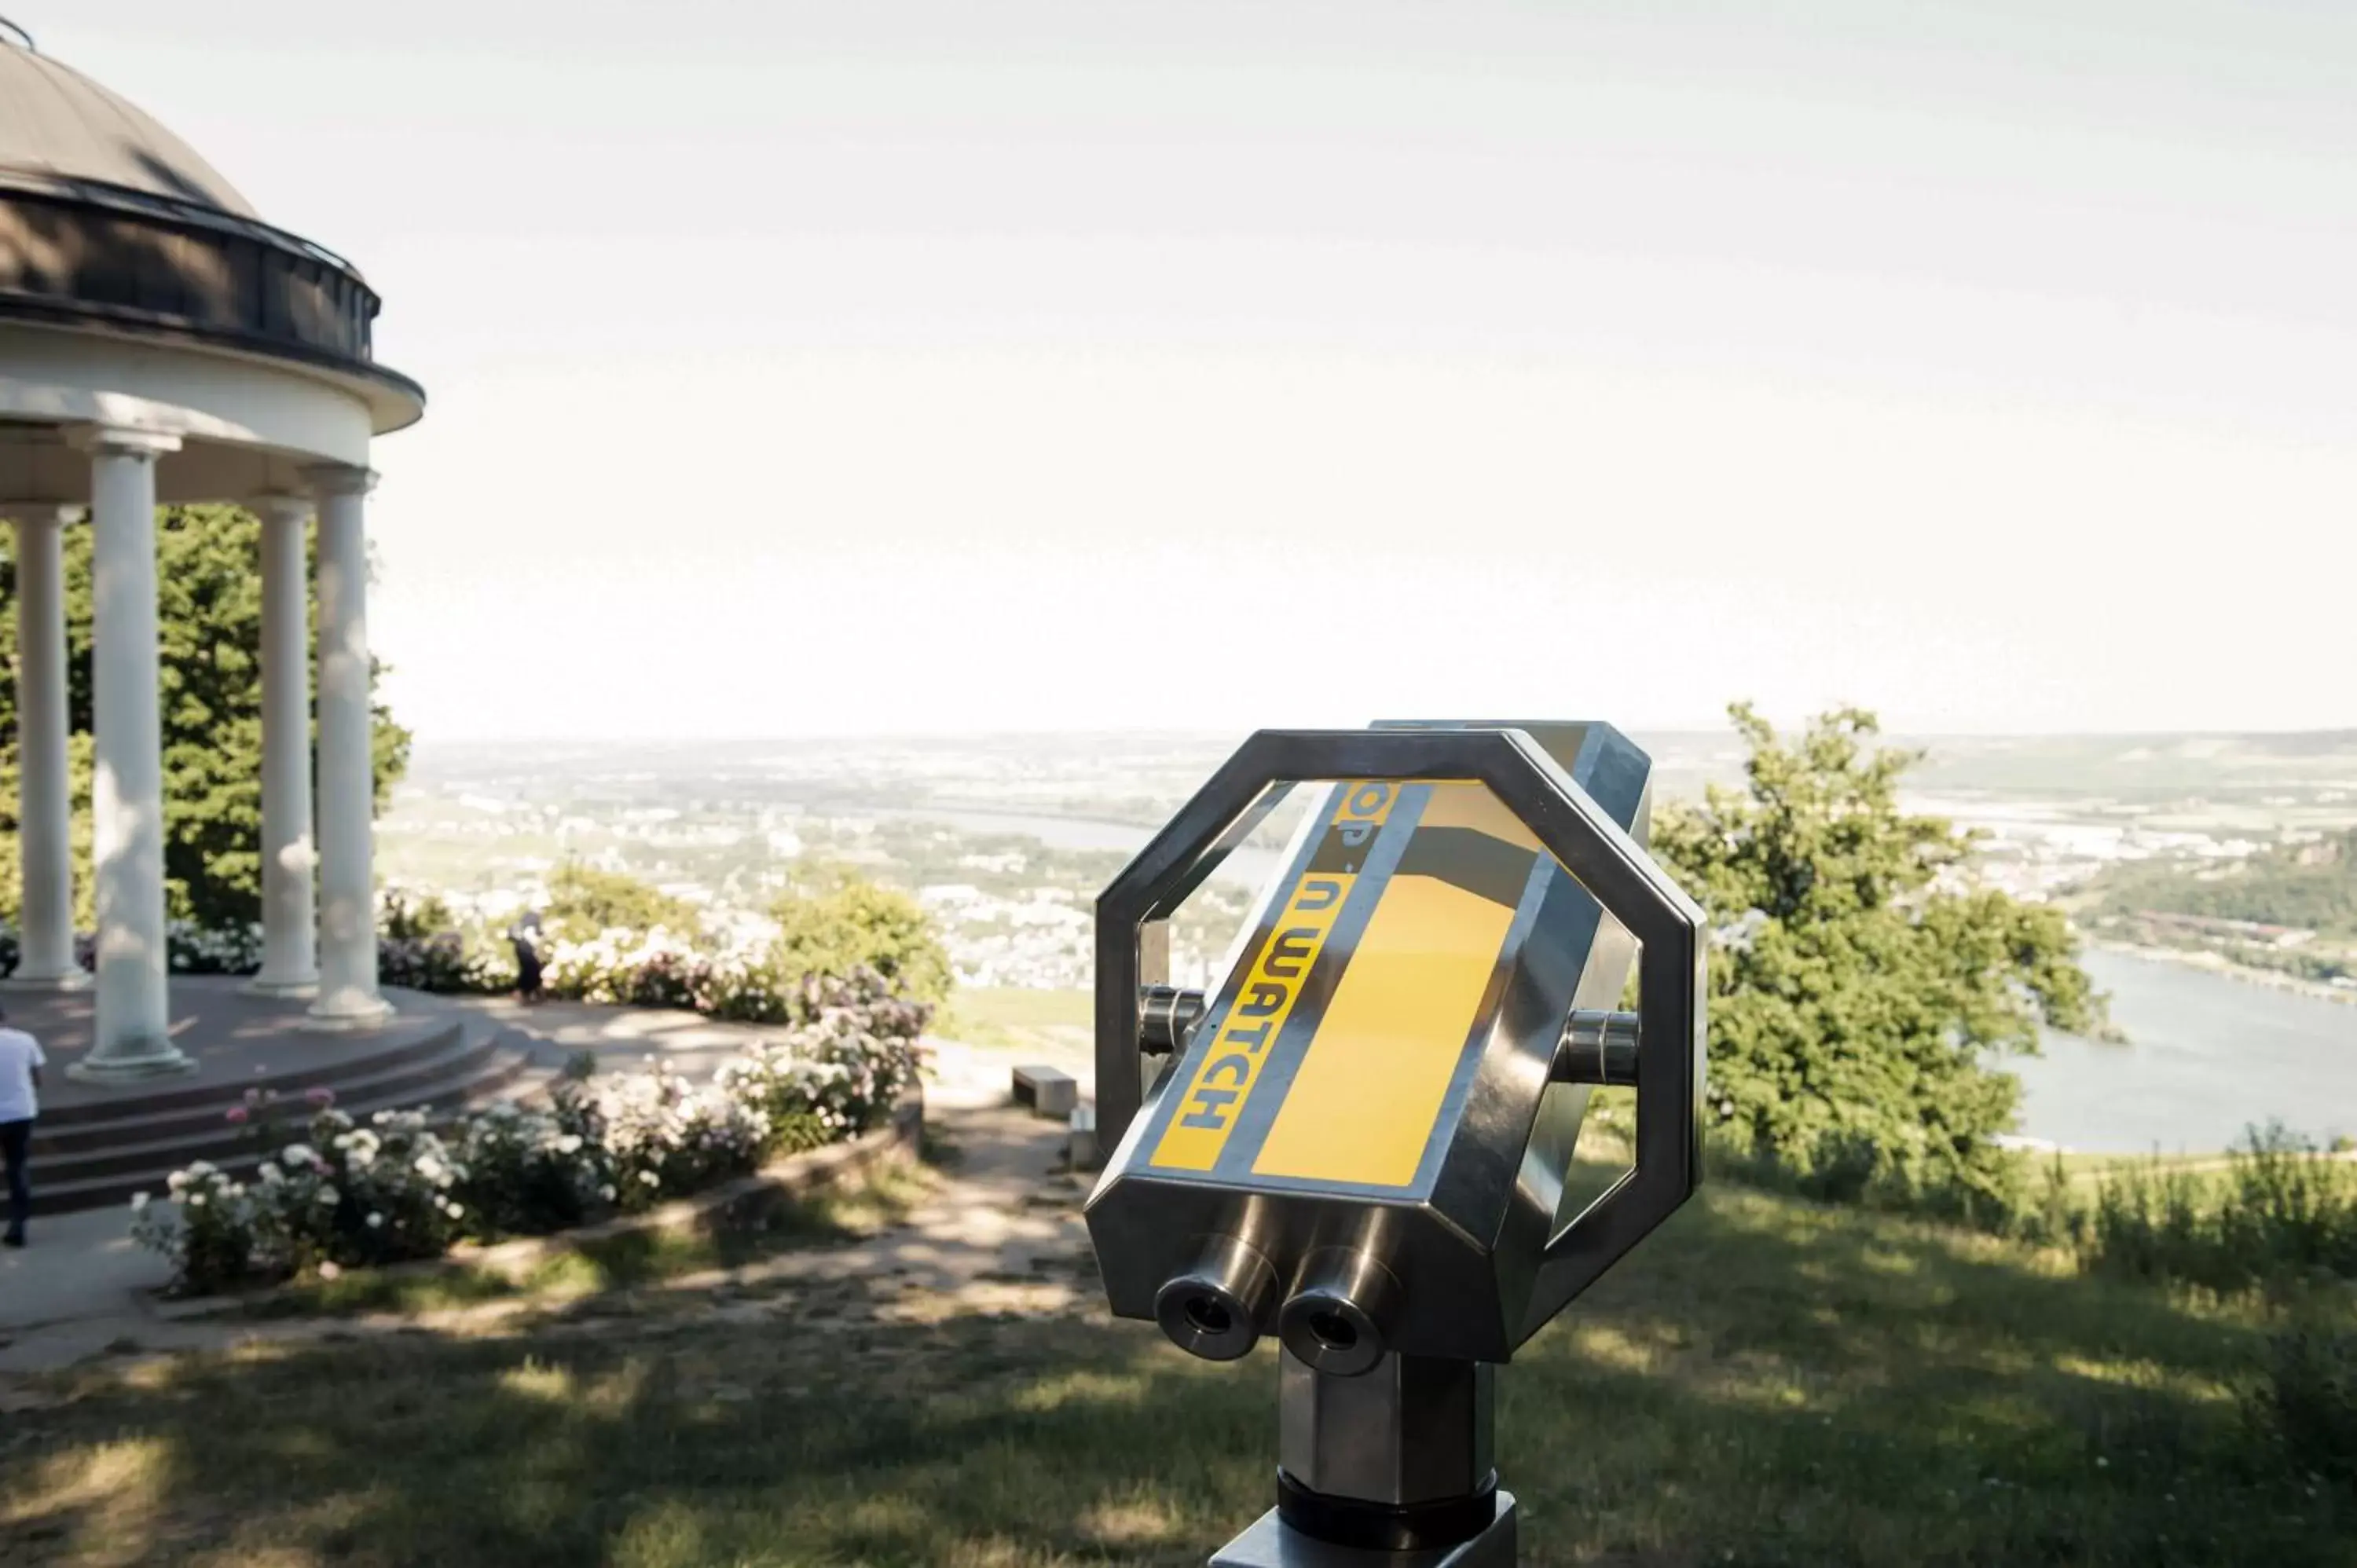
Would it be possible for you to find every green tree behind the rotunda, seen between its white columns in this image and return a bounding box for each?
[0,507,410,929]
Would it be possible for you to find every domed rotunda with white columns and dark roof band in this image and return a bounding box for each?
[0,31,424,1083]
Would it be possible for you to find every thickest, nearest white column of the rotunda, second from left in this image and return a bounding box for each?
[68,429,196,1083]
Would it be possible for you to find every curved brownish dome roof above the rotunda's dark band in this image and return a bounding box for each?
[0,40,259,219]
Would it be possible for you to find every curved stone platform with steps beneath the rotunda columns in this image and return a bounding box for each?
[5,976,533,1214]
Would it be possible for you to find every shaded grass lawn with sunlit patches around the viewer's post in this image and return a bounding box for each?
[0,1160,2357,1568]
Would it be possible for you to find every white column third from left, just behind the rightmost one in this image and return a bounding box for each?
[245,495,318,998]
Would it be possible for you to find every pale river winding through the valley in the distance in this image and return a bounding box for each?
[898,809,2357,1153]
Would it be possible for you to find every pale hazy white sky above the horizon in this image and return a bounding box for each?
[23,0,2357,738]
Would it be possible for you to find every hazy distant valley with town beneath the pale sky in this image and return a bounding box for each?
[377,733,2357,993]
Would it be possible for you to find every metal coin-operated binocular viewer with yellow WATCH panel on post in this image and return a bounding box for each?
[1087,724,1704,1568]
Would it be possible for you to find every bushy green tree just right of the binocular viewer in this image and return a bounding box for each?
[1652,705,2102,1200]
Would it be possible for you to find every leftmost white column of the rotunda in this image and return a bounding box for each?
[9,504,90,991]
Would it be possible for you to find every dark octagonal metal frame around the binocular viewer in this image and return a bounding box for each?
[1096,728,1706,1337]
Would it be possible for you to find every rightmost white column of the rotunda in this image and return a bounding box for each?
[311,469,391,1028]
